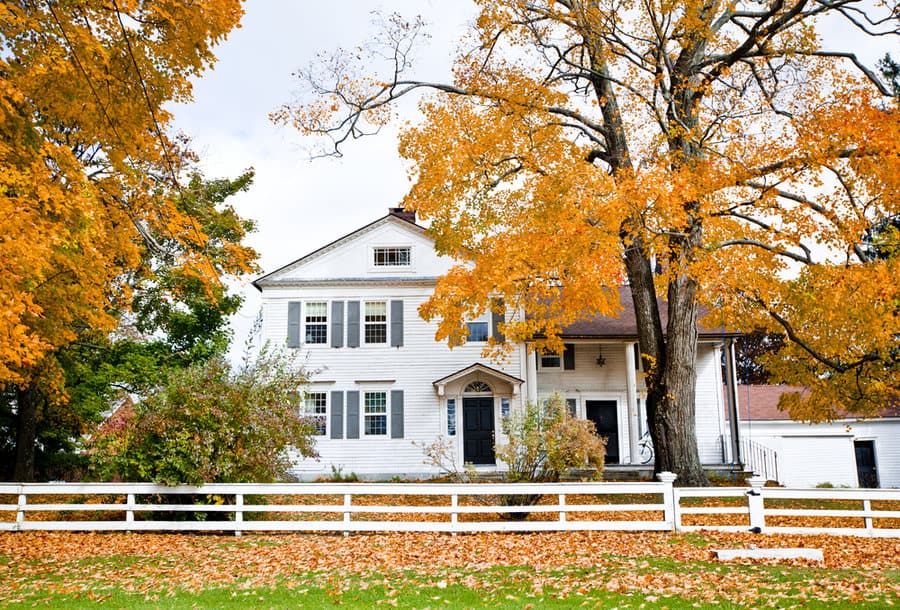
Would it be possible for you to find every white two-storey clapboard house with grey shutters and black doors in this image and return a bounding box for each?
[254,208,752,479]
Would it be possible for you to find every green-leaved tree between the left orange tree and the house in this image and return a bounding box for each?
[0,171,256,480]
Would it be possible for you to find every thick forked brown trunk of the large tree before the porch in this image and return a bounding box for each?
[625,244,709,486]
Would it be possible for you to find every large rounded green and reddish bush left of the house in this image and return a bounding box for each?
[88,349,316,485]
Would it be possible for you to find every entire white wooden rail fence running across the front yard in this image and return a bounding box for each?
[0,473,900,537]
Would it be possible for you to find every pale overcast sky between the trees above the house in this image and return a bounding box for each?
[174,0,884,352]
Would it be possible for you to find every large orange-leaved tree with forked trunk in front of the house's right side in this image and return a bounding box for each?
[274,0,900,485]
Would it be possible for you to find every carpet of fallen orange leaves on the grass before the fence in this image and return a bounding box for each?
[0,532,900,607]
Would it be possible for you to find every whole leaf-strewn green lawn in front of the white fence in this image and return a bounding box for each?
[0,533,900,608]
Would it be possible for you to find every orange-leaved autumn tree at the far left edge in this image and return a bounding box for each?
[0,0,249,480]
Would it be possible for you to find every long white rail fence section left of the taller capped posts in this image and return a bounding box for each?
[0,482,674,532]
